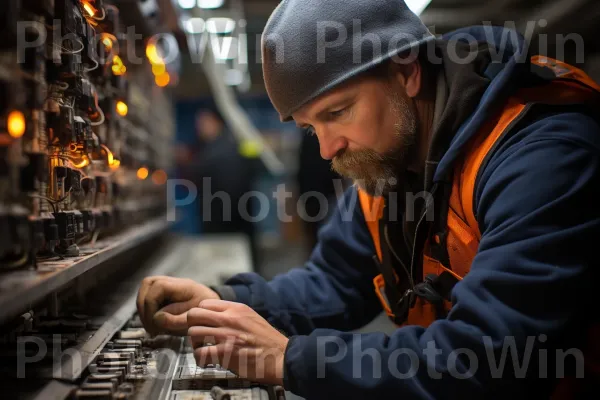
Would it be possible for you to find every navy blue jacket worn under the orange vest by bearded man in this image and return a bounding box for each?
[218,28,600,400]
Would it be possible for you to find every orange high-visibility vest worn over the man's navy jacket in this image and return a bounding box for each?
[359,56,600,398]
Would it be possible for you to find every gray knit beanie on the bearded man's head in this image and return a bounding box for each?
[262,0,435,121]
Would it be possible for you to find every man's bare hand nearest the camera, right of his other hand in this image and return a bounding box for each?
[187,300,288,385]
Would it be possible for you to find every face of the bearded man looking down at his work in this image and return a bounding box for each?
[293,71,418,195]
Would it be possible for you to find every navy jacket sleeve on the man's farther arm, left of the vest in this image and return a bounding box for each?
[216,188,382,335]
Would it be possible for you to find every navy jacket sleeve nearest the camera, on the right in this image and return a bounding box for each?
[284,110,600,400]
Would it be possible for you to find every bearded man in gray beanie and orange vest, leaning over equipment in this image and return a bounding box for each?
[138,0,600,399]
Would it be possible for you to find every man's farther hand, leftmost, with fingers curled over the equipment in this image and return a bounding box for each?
[137,276,219,336]
